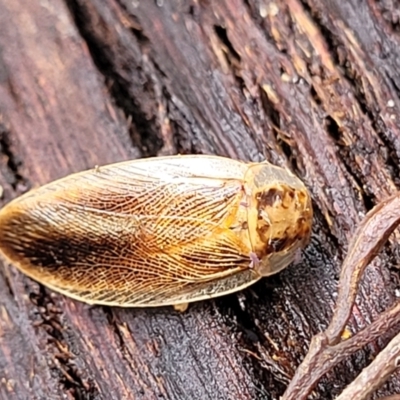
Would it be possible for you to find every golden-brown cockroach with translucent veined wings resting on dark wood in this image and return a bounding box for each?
[0,156,312,307]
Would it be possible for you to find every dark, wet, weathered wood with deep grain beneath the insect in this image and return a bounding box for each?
[0,0,400,399]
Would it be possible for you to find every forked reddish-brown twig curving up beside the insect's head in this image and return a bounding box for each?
[282,194,400,400]
